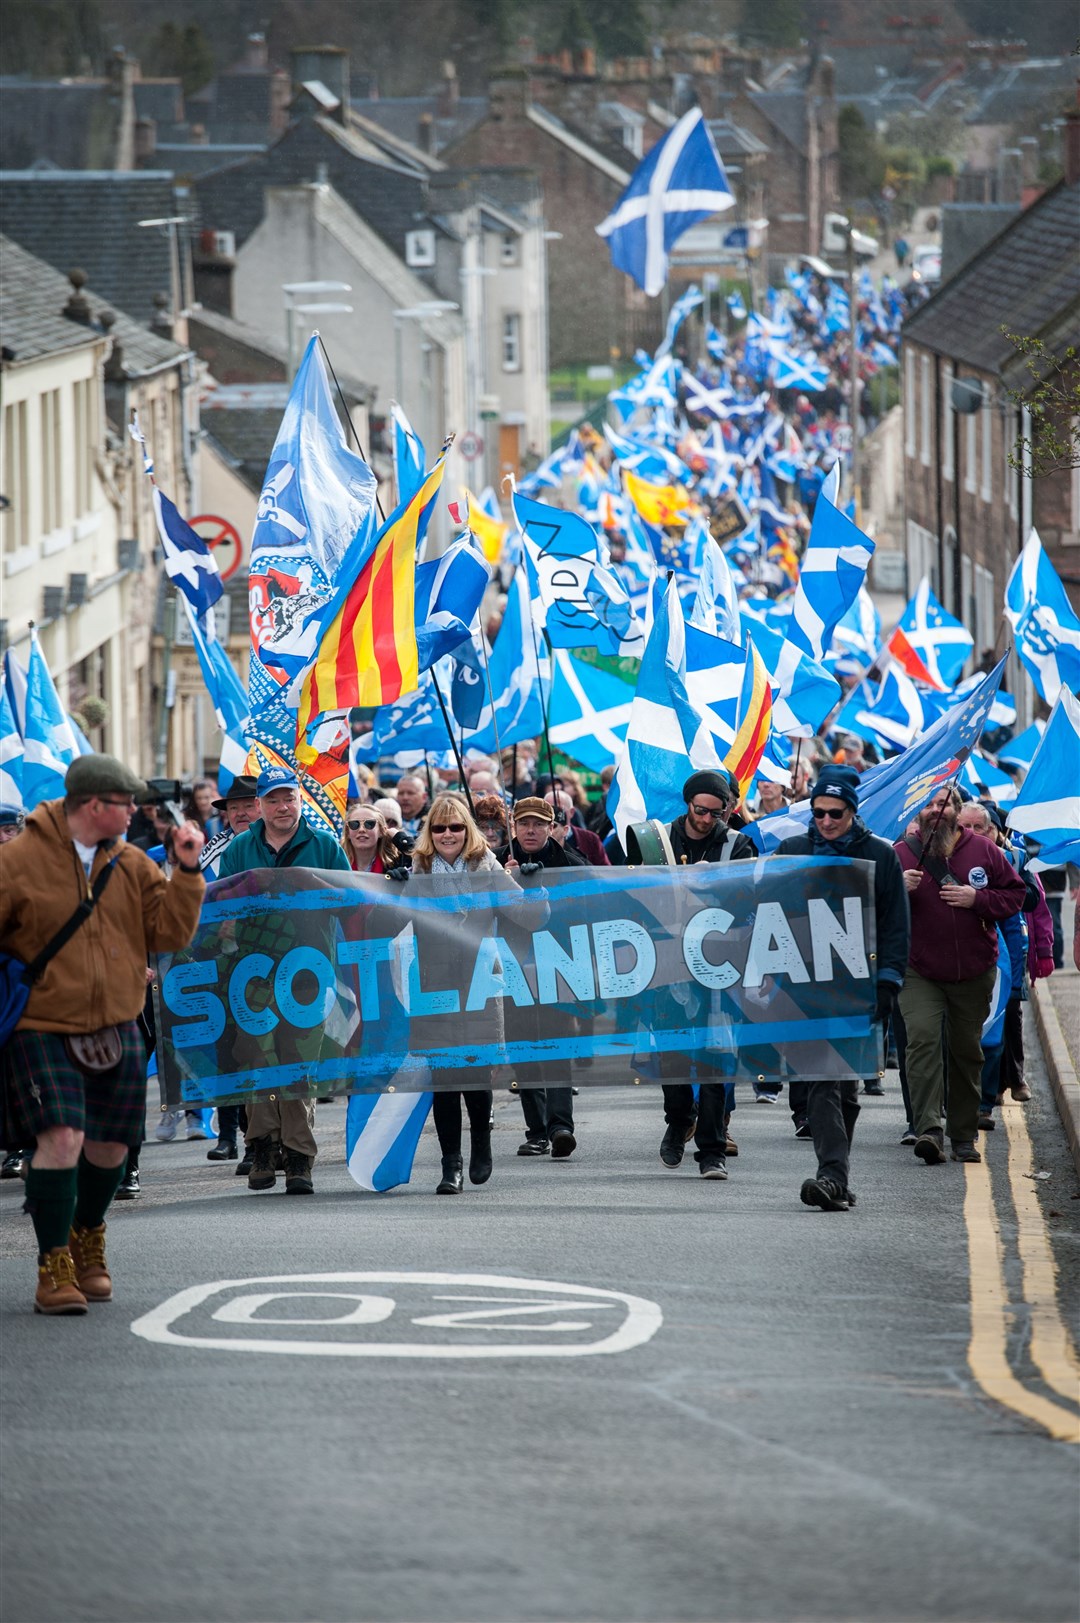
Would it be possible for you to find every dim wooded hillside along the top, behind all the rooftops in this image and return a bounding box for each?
[0,0,1078,96]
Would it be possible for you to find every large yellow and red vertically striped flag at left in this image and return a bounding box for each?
[297,456,445,751]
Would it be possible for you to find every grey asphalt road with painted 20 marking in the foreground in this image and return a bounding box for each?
[0,1038,1080,1623]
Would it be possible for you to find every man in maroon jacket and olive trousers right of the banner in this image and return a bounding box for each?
[895,784,1025,1167]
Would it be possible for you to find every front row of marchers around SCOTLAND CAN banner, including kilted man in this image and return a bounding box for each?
[0,723,1077,1313]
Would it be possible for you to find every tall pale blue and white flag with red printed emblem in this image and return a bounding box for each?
[248,336,377,704]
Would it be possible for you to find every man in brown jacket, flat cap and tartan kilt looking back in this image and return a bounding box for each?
[0,755,205,1313]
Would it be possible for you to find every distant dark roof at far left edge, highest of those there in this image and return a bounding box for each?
[0,76,117,169]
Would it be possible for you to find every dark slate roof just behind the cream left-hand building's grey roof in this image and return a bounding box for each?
[0,169,182,323]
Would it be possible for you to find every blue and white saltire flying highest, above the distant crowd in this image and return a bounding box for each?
[596,107,736,297]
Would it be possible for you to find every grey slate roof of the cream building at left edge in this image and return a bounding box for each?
[0,237,188,377]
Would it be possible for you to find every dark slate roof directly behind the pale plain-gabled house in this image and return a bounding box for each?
[193,118,441,255]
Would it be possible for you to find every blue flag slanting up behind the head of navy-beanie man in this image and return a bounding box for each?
[747,659,1005,852]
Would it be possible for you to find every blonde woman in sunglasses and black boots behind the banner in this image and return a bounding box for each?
[413,794,529,1195]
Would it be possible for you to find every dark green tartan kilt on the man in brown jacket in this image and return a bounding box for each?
[2,1021,146,1149]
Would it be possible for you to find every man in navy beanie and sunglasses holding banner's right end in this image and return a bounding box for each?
[775,766,909,1212]
